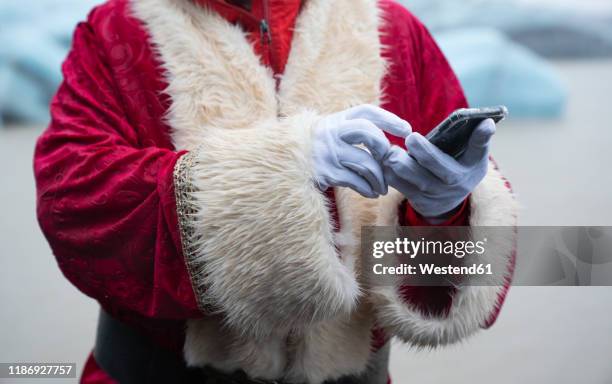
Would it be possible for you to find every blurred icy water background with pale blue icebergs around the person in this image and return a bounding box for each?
[0,0,612,384]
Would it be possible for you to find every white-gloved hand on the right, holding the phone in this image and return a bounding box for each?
[383,119,495,219]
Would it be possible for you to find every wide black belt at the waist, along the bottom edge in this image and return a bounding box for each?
[93,309,389,384]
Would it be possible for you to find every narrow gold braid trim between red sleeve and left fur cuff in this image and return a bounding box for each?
[173,148,209,312]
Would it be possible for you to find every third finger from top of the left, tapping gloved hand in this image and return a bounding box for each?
[338,145,387,195]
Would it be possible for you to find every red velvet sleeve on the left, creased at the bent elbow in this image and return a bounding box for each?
[34,23,200,319]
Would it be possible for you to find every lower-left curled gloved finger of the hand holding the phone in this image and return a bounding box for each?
[383,146,440,192]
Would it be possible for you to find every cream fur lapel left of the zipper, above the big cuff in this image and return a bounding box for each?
[132,0,277,149]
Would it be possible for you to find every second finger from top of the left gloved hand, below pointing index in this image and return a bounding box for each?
[339,119,391,161]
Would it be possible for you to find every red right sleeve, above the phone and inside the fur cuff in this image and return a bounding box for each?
[382,1,470,315]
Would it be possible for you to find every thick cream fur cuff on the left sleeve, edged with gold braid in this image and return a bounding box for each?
[175,113,359,337]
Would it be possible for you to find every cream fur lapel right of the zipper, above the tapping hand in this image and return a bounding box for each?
[278,0,386,115]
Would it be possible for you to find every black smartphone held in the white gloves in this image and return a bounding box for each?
[425,105,508,158]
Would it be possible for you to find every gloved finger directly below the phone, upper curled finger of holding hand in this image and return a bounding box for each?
[406,133,463,185]
